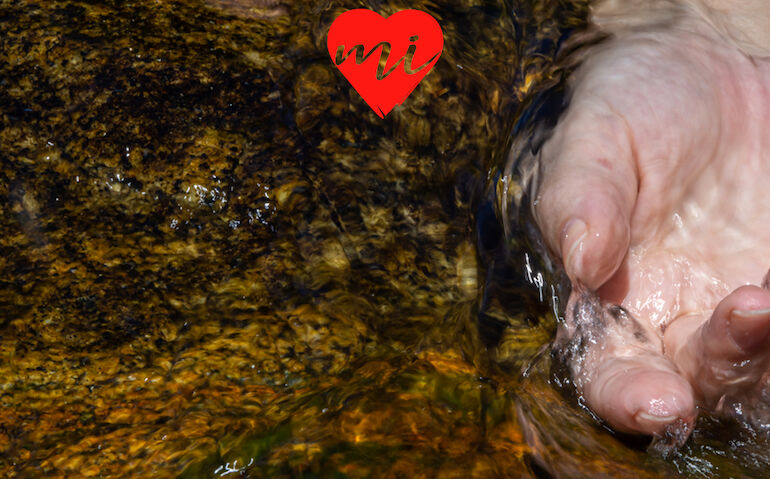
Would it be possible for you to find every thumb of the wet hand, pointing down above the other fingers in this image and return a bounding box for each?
[534,101,638,289]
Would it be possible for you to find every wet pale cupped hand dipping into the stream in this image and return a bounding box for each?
[533,0,770,440]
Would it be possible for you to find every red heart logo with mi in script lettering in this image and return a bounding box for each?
[326,9,444,118]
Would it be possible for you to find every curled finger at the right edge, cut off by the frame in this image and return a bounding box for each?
[664,285,770,407]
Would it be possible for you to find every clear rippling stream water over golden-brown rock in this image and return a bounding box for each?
[0,0,770,478]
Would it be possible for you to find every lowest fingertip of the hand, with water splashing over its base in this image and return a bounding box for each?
[560,290,696,434]
